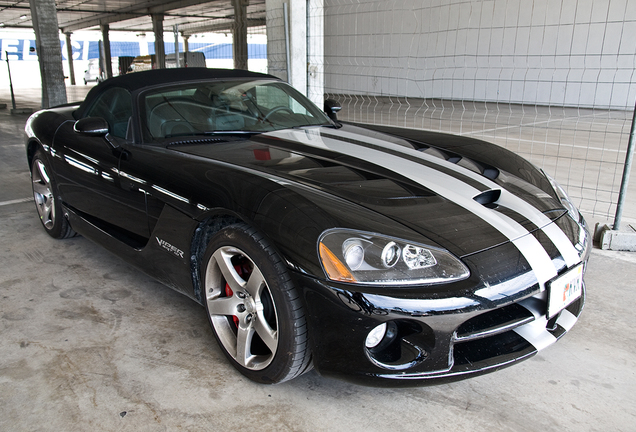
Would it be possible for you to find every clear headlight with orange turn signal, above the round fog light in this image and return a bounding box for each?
[318,228,470,285]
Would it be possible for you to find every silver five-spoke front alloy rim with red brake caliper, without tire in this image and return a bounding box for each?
[205,246,278,370]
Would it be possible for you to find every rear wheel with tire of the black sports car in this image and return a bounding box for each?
[31,151,75,239]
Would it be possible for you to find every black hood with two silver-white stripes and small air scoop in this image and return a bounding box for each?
[169,125,565,257]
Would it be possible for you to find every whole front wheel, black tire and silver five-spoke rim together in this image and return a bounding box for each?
[201,224,311,384]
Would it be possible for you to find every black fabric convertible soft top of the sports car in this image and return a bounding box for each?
[75,68,279,118]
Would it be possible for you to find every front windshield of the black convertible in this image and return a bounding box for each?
[141,80,333,141]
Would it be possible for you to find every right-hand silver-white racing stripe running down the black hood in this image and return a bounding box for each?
[338,131,581,275]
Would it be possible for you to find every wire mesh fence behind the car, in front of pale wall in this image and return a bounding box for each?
[308,0,636,221]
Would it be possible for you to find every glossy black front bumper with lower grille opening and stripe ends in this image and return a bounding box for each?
[299,277,585,386]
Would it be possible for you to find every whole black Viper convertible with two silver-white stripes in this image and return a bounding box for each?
[26,69,590,386]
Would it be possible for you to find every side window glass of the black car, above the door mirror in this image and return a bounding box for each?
[86,87,132,138]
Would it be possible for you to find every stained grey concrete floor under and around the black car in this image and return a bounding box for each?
[0,88,636,432]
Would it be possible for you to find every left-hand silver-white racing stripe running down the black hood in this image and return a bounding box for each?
[267,130,557,289]
